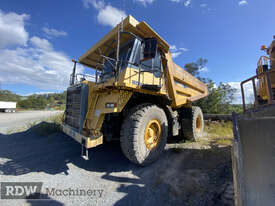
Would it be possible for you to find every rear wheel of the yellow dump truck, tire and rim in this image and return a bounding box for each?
[182,107,204,141]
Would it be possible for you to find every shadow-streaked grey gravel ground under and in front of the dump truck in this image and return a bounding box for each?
[0,124,233,206]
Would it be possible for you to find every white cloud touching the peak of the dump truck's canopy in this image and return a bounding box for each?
[83,0,127,27]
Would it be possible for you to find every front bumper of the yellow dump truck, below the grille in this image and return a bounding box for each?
[61,124,103,149]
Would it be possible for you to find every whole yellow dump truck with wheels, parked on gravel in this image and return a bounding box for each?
[62,16,208,165]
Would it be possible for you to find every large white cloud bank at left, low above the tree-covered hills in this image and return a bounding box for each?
[0,37,77,90]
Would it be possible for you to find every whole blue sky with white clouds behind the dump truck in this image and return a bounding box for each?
[0,0,275,102]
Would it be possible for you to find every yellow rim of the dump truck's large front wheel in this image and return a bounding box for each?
[144,119,161,150]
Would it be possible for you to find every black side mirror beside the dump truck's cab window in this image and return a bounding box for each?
[140,38,158,61]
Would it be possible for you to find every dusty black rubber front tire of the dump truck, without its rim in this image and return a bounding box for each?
[120,104,168,166]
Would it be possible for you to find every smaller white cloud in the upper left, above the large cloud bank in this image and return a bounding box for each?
[0,10,29,48]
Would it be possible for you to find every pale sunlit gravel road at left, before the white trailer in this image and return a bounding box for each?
[0,111,60,133]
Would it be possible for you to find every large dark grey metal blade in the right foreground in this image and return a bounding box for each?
[232,114,275,206]
